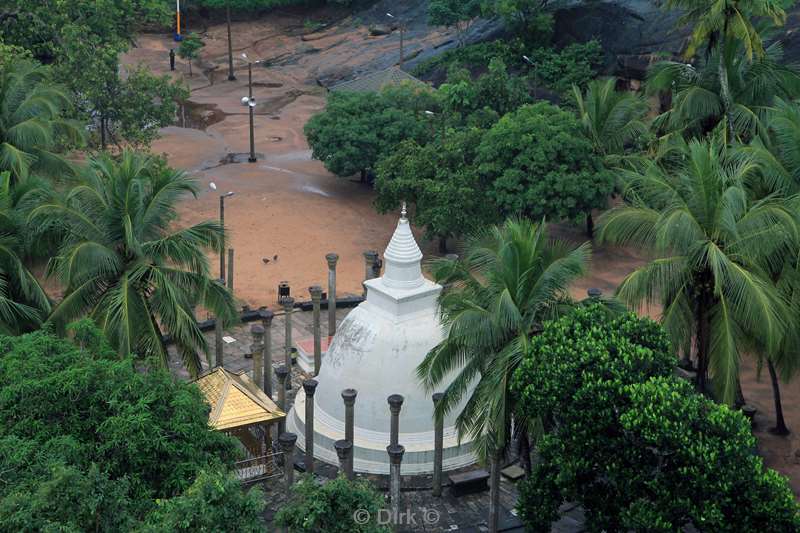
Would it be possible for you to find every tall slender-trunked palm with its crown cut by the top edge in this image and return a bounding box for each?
[666,0,786,142]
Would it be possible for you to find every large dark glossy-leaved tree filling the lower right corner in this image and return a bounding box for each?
[513,307,800,533]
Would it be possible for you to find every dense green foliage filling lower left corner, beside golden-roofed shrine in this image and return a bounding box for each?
[0,324,261,531]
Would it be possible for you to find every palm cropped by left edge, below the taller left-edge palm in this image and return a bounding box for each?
[0,171,50,335]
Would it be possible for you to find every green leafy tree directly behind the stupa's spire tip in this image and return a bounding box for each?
[375,128,496,253]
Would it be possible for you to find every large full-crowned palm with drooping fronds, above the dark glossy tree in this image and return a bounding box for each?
[600,140,800,403]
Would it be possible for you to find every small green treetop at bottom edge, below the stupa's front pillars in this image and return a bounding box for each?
[275,476,389,533]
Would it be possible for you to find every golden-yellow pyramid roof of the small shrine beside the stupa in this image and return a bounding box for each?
[194,367,286,430]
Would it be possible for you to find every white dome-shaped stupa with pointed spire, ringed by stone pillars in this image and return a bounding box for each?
[287,207,475,474]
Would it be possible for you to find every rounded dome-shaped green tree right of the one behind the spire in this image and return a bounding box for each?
[476,102,614,236]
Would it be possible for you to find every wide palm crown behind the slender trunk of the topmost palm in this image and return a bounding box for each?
[646,41,800,140]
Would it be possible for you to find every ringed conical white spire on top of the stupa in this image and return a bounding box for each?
[382,202,425,289]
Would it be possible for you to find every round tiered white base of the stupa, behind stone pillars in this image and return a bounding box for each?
[286,389,476,475]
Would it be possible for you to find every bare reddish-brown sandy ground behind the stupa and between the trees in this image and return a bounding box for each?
[126,15,800,493]
